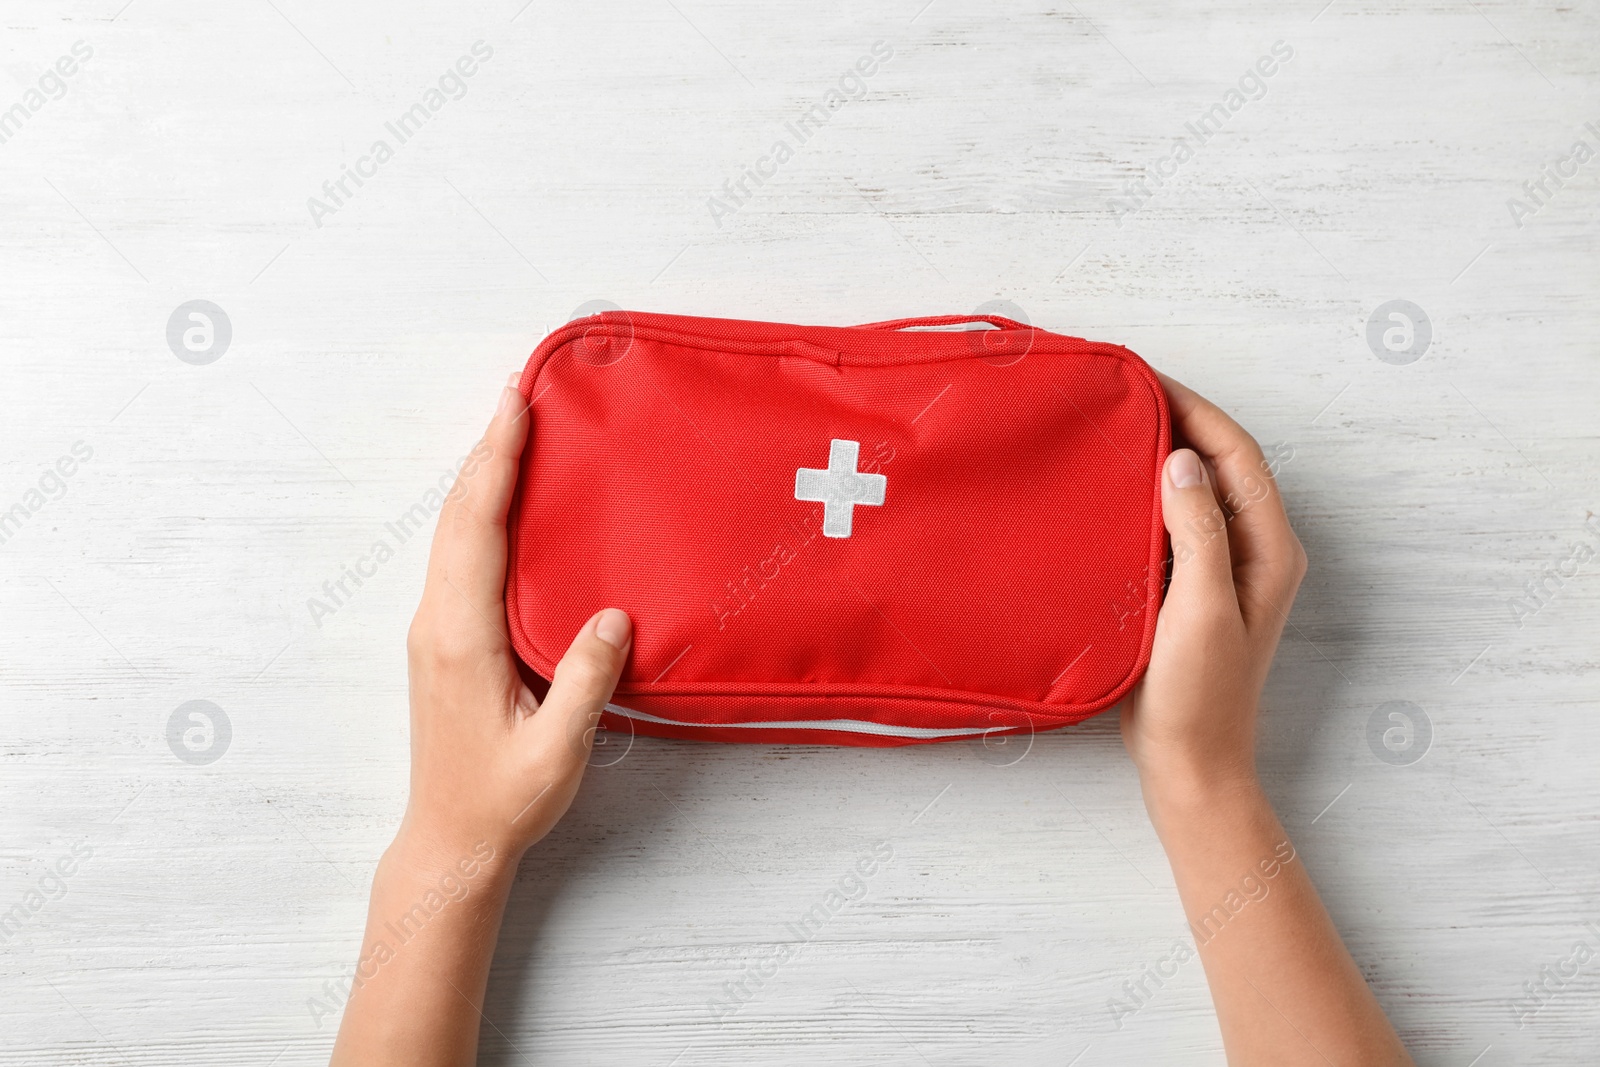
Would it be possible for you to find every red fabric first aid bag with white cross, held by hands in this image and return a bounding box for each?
[506,310,1170,745]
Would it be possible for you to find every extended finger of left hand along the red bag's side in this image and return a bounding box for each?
[429,375,530,614]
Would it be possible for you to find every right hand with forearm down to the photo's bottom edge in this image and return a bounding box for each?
[1122,378,1411,1067]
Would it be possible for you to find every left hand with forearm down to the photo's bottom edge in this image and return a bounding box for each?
[331,378,632,1067]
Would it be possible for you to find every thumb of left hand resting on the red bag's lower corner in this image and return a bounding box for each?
[531,608,634,765]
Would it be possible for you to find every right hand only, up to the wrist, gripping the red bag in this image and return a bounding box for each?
[1122,374,1306,790]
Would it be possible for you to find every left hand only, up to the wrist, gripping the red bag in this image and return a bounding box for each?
[400,375,632,856]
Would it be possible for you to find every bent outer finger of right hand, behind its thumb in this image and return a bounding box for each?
[1160,374,1304,613]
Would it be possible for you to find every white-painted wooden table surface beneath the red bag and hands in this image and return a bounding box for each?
[0,0,1600,1067]
